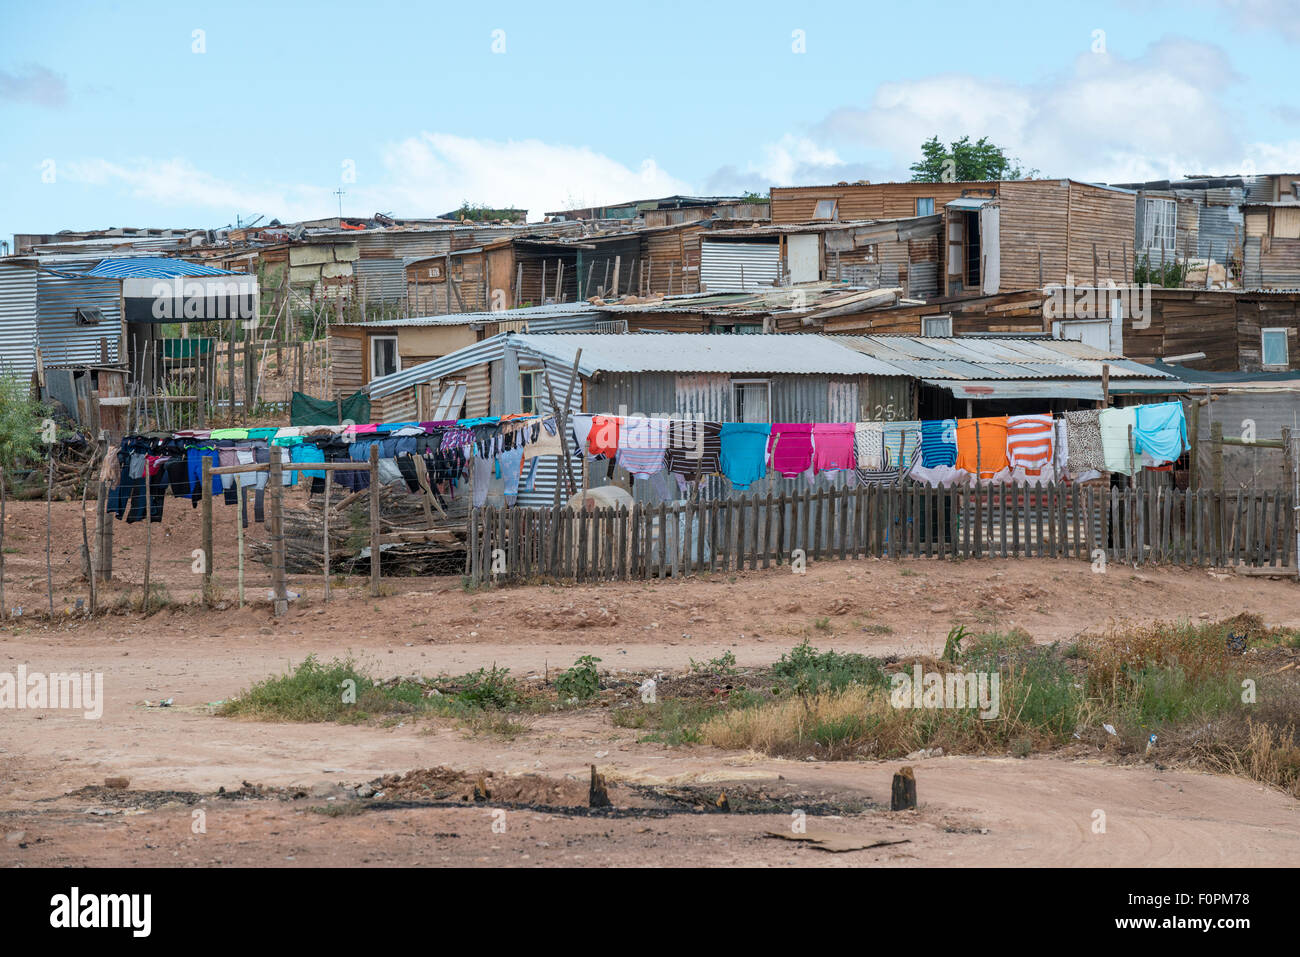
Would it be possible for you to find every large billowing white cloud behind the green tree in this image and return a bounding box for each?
[728,38,1296,183]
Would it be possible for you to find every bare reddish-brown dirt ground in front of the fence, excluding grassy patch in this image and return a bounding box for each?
[0,499,1300,866]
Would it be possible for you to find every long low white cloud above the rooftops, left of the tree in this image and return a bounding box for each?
[59,133,690,222]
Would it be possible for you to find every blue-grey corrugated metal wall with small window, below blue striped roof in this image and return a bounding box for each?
[36,267,122,367]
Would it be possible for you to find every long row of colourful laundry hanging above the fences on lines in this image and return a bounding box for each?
[103,400,1188,521]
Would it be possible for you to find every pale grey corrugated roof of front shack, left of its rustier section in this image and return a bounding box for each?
[511,333,902,376]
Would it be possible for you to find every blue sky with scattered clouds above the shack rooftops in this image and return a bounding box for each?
[0,0,1300,241]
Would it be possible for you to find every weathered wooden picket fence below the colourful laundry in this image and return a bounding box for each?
[467,485,1296,585]
